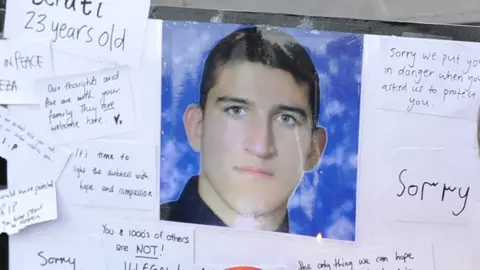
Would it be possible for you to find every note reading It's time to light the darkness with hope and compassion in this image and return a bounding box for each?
[62,141,158,210]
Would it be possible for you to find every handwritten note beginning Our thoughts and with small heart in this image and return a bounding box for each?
[35,67,135,142]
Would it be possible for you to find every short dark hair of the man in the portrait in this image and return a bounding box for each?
[200,26,320,125]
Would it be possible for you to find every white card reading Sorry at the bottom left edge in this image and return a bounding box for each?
[18,235,107,270]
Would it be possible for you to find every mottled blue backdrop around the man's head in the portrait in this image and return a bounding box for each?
[160,21,363,240]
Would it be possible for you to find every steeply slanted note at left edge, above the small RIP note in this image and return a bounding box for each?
[0,107,71,185]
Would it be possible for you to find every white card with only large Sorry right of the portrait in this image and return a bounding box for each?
[383,148,480,224]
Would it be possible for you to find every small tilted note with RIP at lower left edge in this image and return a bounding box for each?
[0,180,57,235]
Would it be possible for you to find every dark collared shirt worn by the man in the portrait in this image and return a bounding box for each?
[160,176,289,233]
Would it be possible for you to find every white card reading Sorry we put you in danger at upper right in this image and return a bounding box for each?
[367,36,480,120]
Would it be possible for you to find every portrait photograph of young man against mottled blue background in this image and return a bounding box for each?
[160,21,363,240]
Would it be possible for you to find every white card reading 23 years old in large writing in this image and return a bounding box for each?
[4,0,150,67]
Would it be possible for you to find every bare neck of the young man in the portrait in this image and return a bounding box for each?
[198,174,287,231]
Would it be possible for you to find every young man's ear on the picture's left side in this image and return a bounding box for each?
[183,105,203,152]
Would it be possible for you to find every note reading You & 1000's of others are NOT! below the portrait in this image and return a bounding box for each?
[99,223,194,270]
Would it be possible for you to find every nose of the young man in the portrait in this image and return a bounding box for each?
[245,117,277,159]
